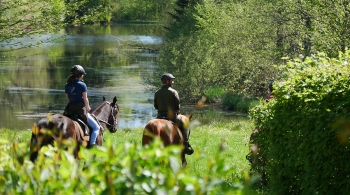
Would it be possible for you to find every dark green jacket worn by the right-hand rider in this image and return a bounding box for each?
[154,85,180,119]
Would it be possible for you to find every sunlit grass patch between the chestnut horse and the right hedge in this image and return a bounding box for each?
[188,116,252,181]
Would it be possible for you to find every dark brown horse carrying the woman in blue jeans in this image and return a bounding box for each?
[30,97,119,162]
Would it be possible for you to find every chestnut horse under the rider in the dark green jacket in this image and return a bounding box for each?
[142,114,192,167]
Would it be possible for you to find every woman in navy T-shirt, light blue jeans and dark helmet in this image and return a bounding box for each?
[64,65,100,147]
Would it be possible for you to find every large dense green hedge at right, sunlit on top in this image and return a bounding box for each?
[248,51,350,194]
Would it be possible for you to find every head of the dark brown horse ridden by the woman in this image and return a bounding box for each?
[92,97,119,133]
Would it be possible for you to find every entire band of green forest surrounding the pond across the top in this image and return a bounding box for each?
[0,0,350,101]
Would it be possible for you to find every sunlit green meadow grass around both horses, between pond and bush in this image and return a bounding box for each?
[0,110,253,182]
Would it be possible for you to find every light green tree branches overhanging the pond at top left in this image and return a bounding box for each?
[0,0,65,52]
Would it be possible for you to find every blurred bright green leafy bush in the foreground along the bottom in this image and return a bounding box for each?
[0,136,254,194]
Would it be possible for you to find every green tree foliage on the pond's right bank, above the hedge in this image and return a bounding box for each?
[149,0,350,103]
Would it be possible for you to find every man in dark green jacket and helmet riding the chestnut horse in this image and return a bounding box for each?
[154,73,194,155]
